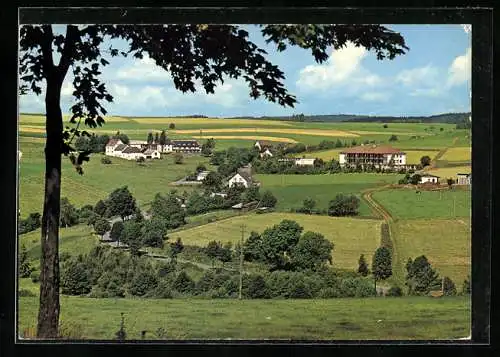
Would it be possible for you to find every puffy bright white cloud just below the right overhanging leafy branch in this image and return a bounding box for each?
[296,43,382,90]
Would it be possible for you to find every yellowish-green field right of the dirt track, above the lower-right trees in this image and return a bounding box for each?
[393,218,471,291]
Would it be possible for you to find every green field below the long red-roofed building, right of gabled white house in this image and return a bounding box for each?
[255,173,404,216]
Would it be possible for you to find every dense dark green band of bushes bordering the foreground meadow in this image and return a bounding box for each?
[61,243,375,299]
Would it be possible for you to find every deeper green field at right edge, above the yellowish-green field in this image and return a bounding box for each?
[373,189,471,219]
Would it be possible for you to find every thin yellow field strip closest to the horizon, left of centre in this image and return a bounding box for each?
[129,118,291,126]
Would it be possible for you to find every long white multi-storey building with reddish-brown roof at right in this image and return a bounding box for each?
[339,145,406,167]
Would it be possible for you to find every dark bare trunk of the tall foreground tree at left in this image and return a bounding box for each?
[37,78,63,338]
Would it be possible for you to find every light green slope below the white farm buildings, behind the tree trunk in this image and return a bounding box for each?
[19,137,210,217]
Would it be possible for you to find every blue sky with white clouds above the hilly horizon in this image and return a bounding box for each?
[19,24,471,117]
